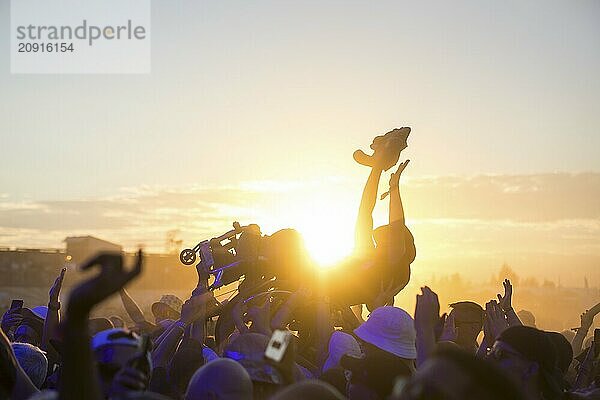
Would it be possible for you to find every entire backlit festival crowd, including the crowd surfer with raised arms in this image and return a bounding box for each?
[0,128,600,400]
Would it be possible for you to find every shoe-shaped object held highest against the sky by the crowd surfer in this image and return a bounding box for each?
[353,127,410,171]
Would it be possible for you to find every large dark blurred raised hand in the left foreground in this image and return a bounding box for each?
[68,250,143,317]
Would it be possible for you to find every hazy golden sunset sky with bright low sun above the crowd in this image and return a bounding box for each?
[0,0,600,284]
